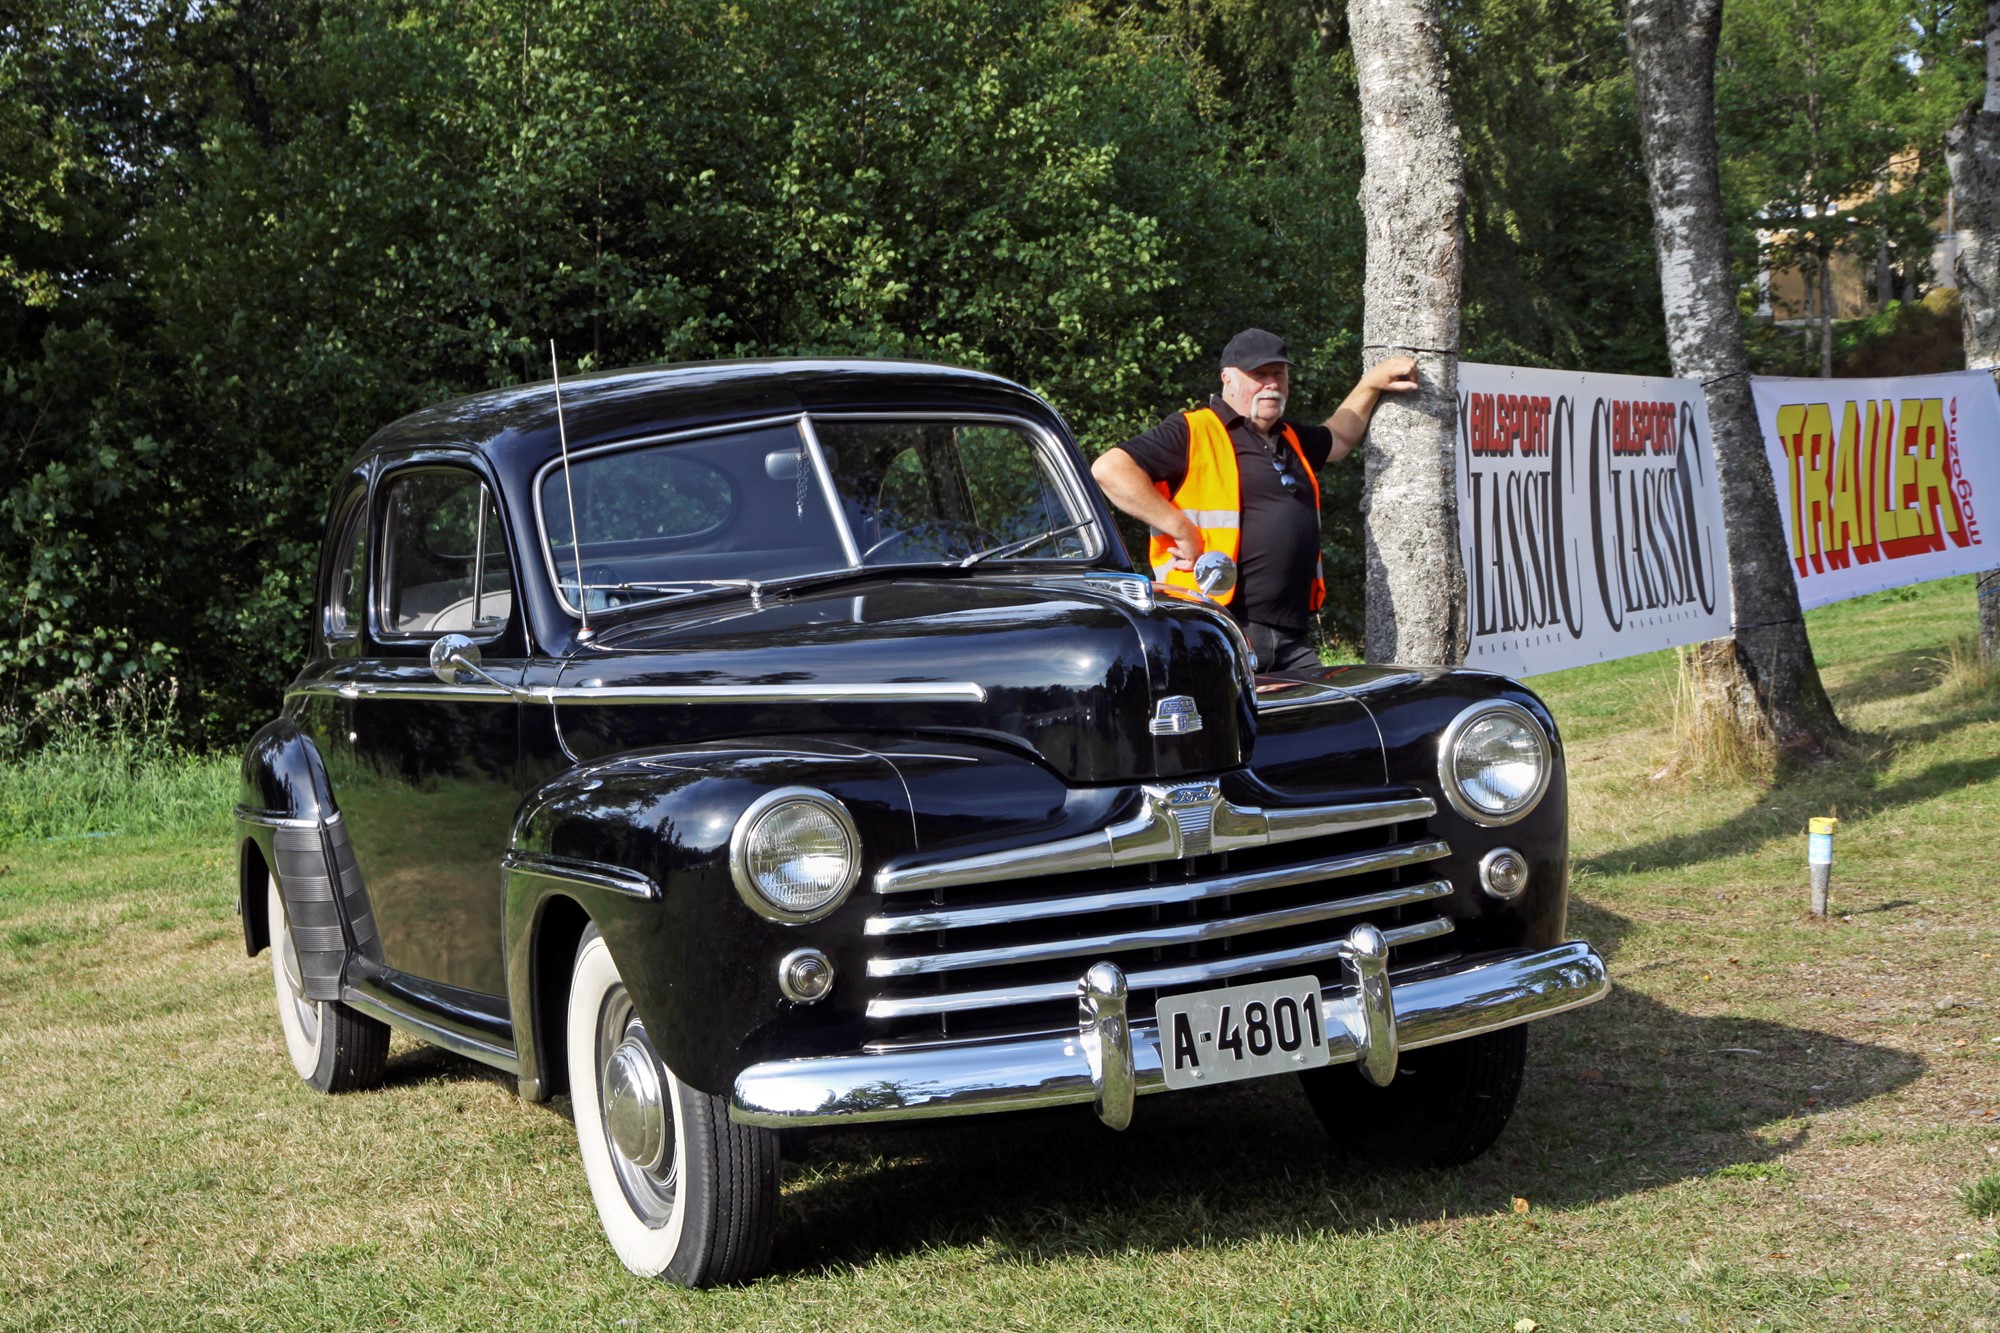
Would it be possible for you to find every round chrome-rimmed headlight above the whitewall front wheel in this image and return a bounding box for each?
[730,787,862,923]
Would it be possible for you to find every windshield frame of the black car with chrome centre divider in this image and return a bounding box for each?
[530,410,1108,620]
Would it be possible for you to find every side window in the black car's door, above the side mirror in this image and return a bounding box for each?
[378,470,514,638]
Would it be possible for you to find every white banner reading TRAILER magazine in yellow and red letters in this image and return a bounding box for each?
[1750,370,2000,606]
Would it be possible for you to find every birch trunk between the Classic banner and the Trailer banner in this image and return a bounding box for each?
[1628,0,1842,753]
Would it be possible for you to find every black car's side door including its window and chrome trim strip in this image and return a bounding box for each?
[336,452,526,996]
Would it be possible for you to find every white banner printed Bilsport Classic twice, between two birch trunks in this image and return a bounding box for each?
[1458,362,1730,677]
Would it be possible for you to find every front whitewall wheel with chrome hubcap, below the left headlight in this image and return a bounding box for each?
[568,927,778,1287]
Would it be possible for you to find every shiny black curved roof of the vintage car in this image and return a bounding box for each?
[356,358,1060,470]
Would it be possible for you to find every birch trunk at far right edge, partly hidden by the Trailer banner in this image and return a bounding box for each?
[1944,0,2000,662]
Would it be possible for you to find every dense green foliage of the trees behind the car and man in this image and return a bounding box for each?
[0,0,1980,745]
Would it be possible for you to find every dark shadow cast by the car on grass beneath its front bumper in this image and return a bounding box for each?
[756,892,1924,1273]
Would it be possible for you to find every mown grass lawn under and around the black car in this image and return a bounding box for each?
[0,580,2000,1331]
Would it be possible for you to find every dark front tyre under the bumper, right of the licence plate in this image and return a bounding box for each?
[1298,1025,1528,1167]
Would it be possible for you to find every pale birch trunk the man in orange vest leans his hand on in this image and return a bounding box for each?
[1348,0,1466,662]
